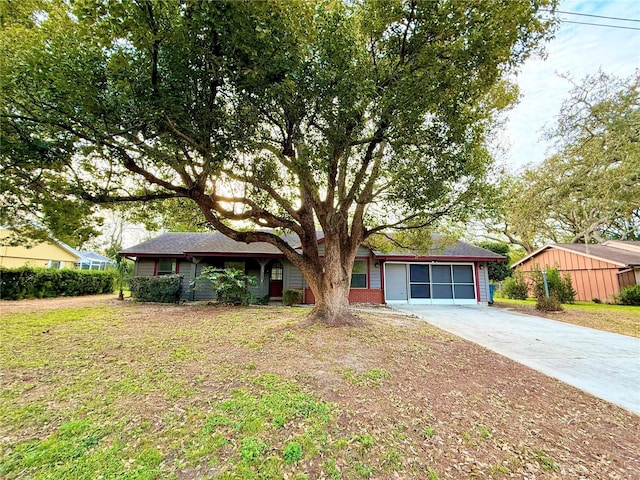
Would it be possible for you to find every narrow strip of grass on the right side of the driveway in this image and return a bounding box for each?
[493,298,640,337]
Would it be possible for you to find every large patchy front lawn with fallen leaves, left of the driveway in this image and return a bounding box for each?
[0,301,640,480]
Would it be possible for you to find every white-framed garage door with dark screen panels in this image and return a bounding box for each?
[385,262,477,305]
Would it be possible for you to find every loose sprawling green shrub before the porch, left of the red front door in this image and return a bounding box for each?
[192,267,256,305]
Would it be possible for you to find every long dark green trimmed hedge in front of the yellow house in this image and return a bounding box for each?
[0,267,117,300]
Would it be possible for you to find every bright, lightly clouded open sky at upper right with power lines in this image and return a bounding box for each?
[499,0,640,171]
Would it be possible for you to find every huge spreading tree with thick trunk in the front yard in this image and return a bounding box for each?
[0,0,554,323]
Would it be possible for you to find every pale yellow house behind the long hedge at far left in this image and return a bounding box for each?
[0,228,114,270]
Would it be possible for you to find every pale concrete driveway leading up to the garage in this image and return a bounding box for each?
[393,305,640,414]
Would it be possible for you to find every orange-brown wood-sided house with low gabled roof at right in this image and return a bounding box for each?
[512,240,640,302]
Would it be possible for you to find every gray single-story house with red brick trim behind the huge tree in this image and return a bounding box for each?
[120,232,505,304]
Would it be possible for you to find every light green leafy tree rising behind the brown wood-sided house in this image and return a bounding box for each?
[484,72,640,252]
